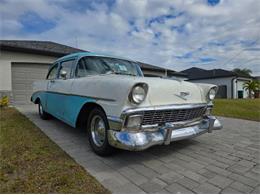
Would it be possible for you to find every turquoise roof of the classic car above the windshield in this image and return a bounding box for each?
[54,52,135,63]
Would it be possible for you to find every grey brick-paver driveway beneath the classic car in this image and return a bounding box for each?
[18,105,260,193]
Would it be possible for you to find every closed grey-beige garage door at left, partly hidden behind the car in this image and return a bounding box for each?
[12,63,49,104]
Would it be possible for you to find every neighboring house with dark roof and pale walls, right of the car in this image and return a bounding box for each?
[181,67,252,99]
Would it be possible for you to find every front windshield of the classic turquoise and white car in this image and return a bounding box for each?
[76,56,142,77]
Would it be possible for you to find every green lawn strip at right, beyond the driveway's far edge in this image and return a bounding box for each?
[213,99,260,121]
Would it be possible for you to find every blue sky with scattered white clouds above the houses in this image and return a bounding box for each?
[0,0,260,75]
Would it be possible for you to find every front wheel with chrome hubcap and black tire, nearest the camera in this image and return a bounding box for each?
[87,108,113,156]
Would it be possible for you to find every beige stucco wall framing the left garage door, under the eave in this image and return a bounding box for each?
[0,51,57,92]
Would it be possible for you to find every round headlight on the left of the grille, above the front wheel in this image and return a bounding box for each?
[129,83,148,104]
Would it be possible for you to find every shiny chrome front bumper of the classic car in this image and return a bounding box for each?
[108,116,222,151]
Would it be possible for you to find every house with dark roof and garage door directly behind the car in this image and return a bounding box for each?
[0,40,183,104]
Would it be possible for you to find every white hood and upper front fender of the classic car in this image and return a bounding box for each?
[74,74,212,106]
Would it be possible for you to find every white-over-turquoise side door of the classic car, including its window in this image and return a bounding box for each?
[47,59,75,124]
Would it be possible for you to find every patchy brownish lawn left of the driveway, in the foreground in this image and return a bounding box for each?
[0,108,109,193]
